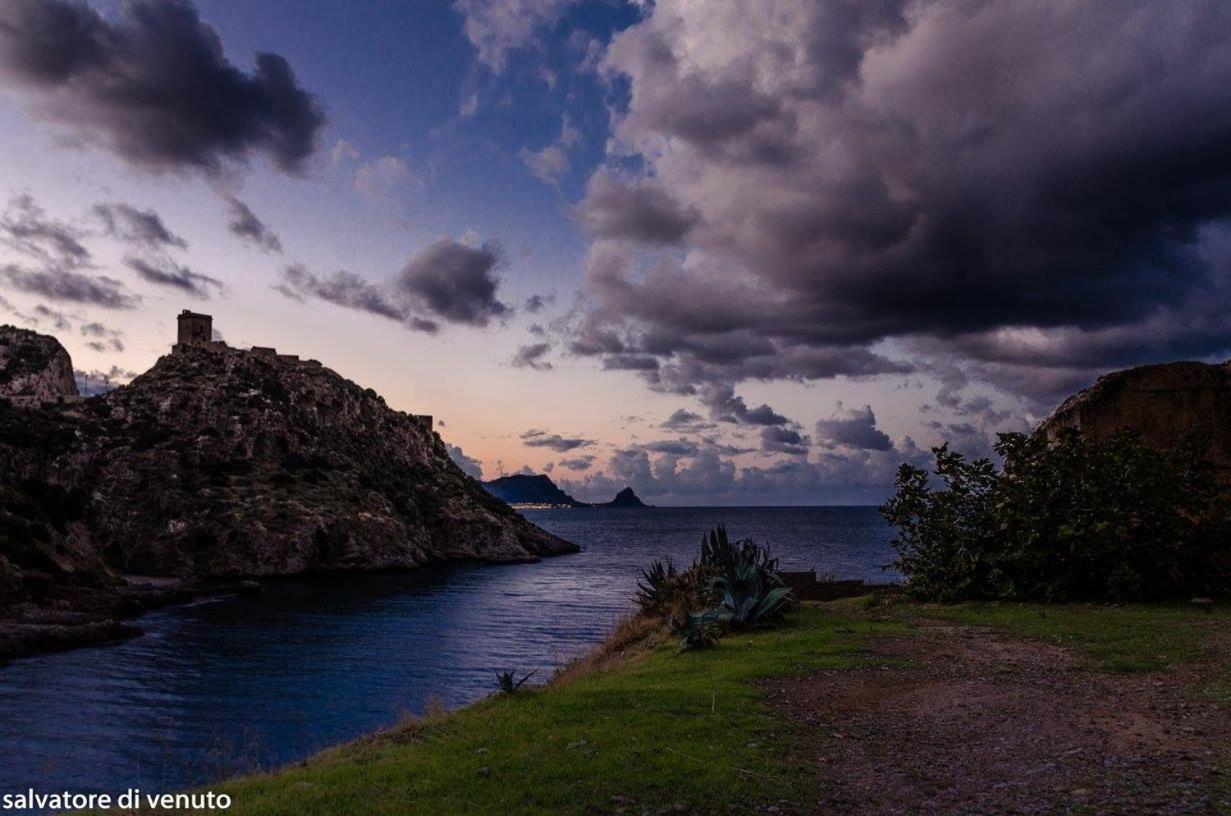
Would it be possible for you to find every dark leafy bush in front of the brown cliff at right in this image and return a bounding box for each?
[881,430,1231,602]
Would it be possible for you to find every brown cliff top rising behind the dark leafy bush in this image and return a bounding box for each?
[1039,363,1231,479]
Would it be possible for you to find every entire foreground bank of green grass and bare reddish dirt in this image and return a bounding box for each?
[209,596,1231,815]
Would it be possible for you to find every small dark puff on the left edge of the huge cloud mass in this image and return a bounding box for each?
[577,170,697,245]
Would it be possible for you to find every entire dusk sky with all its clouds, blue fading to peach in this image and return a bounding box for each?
[0,0,1231,505]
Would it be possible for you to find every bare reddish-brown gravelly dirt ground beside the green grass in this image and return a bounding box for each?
[768,624,1231,816]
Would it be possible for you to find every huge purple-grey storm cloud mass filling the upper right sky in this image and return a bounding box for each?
[572,0,1231,394]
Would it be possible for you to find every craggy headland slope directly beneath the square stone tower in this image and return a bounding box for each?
[0,348,576,577]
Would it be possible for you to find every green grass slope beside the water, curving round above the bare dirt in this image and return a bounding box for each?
[214,603,1231,815]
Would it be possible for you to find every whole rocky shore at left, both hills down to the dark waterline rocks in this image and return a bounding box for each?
[0,327,577,658]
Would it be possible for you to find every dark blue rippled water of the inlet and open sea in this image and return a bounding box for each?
[0,508,894,793]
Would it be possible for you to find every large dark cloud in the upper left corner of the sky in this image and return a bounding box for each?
[0,0,325,174]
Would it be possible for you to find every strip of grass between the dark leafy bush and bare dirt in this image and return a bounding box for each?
[881,603,1231,673]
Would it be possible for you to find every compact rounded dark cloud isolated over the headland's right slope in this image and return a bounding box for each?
[394,238,510,326]
